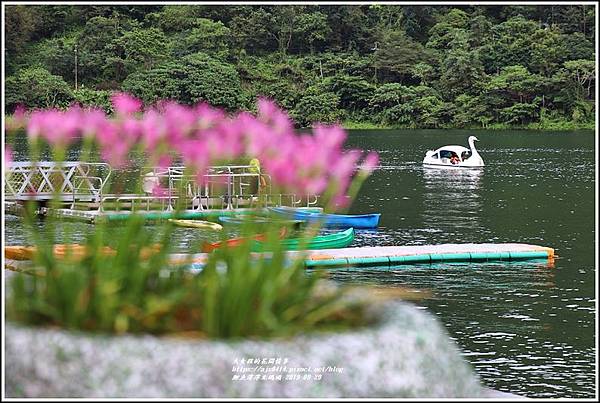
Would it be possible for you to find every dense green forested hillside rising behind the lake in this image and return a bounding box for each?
[5,4,596,129]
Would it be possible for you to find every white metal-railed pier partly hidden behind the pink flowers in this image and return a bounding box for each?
[4,161,318,211]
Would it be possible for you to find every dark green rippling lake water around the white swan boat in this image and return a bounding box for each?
[5,130,596,398]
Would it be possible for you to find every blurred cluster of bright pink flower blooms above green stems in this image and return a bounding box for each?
[12,93,379,211]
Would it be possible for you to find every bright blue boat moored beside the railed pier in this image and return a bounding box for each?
[269,207,381,228]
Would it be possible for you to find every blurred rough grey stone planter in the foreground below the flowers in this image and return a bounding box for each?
[5,302,508,399]
